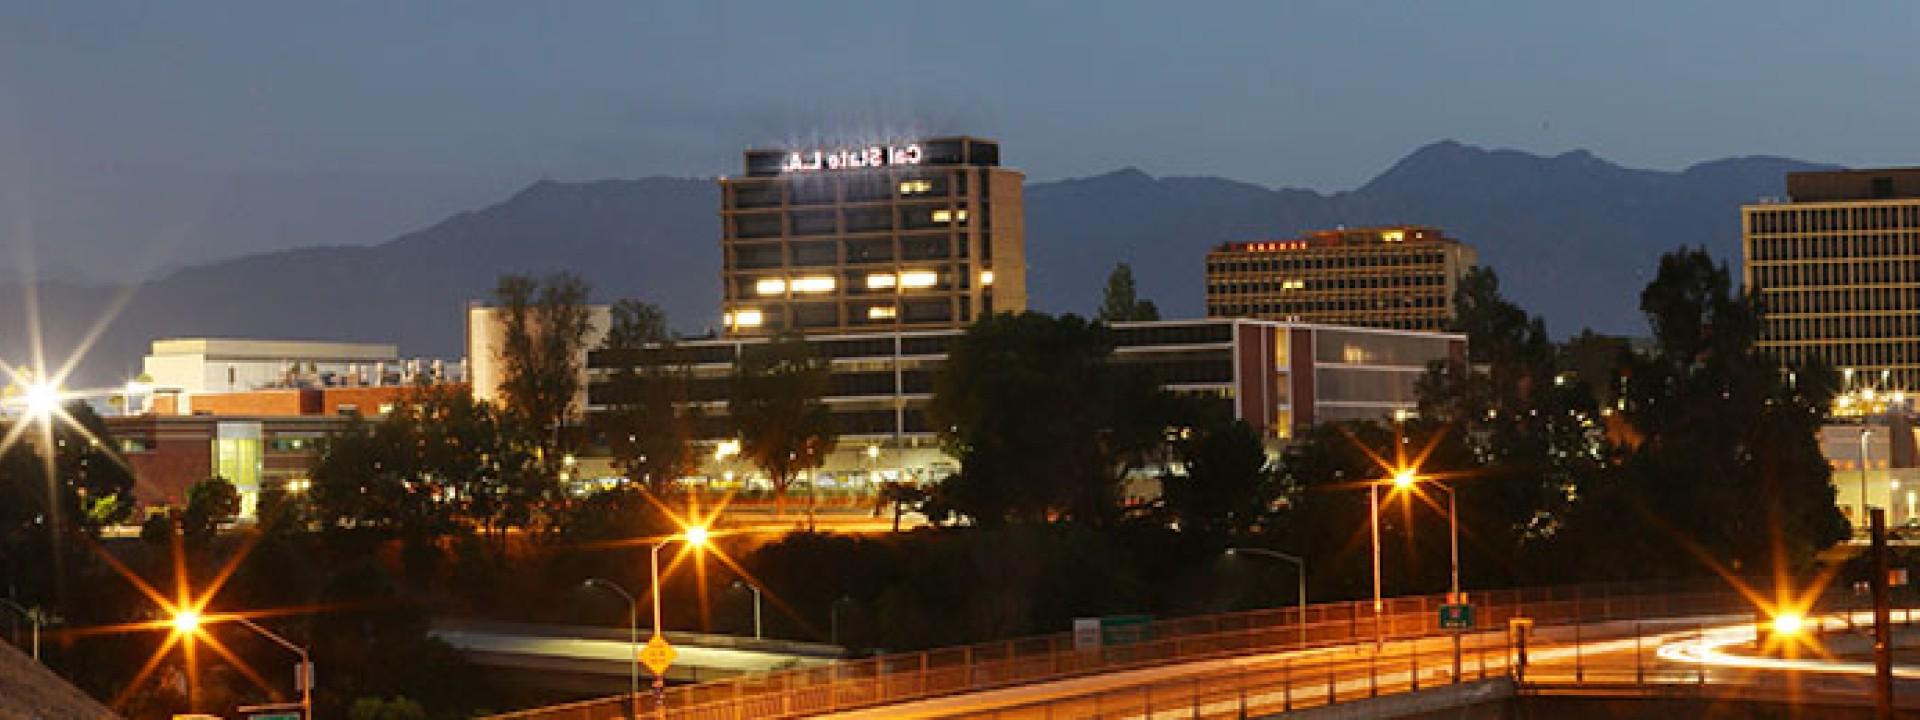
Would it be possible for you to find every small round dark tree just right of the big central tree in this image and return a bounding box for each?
[1160,420,1283,540]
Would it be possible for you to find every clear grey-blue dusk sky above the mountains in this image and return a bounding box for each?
[0,2,1920,275]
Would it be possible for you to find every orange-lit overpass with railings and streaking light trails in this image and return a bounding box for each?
[480,580,1920,720]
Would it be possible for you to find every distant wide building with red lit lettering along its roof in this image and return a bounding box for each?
[1206,225,1476,330]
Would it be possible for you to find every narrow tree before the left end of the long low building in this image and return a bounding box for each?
[595,300,695,495]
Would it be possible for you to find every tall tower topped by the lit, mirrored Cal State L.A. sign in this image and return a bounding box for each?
[720,136,1027,336]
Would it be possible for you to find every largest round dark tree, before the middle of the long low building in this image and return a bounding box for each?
[929,313,1169,526]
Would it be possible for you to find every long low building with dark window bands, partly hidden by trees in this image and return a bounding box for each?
[588,319,1467,482]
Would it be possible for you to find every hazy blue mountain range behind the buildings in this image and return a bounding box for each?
[0,140,1828,384]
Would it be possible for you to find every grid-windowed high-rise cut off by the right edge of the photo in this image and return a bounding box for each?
[1740,167,1920,392]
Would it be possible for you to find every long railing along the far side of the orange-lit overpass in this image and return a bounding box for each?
[495,578,1774,720]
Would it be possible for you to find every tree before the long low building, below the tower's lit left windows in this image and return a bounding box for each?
[728,334,835,515]
